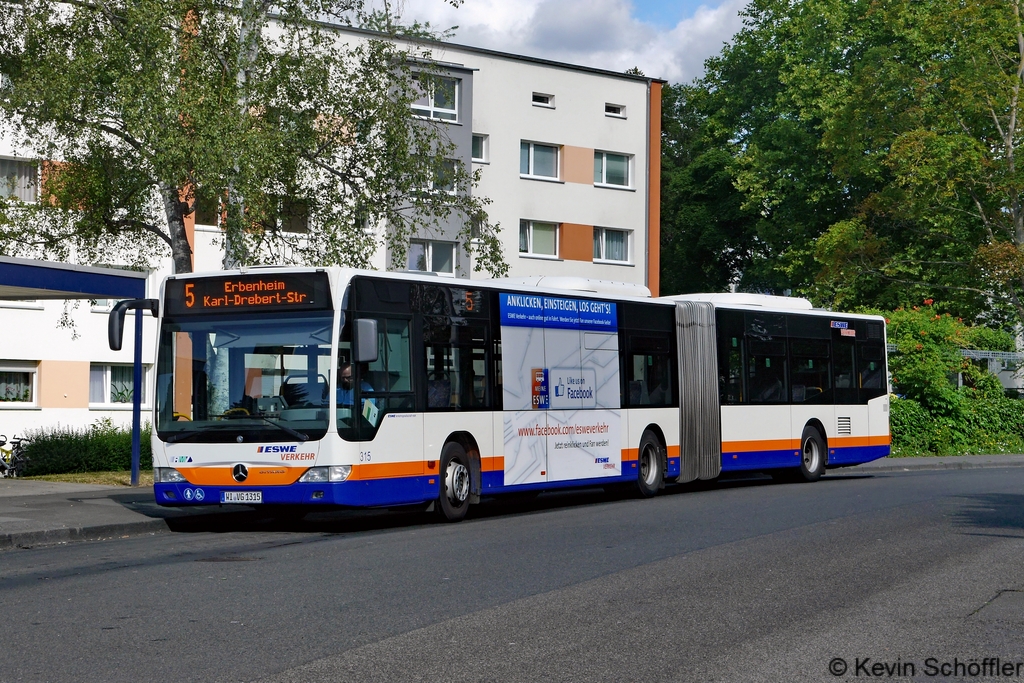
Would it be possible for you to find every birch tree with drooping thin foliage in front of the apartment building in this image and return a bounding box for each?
[0,0,507,274]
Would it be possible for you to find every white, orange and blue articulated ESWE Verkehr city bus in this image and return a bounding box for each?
[119,267,889,520]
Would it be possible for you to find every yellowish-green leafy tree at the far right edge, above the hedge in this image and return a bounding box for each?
[822,0,1024,322]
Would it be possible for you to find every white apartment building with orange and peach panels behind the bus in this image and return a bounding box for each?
[0,28,663,436]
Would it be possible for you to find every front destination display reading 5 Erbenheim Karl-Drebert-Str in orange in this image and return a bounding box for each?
[164,272,331,315]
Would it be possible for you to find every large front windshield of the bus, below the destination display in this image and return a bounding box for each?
[157,311,334,442]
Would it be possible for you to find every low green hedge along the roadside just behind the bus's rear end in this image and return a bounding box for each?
[889,396,1024,457]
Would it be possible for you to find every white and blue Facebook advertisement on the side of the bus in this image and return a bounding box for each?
[500,293,622,485]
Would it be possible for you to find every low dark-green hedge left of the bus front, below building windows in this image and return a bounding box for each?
[25,419,153,476]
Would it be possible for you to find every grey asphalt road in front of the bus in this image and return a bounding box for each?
[0,468,1024,682]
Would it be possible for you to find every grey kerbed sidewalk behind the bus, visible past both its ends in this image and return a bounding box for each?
[6,455,1024,551]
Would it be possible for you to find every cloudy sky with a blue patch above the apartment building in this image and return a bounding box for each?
[389,0,749,83]
